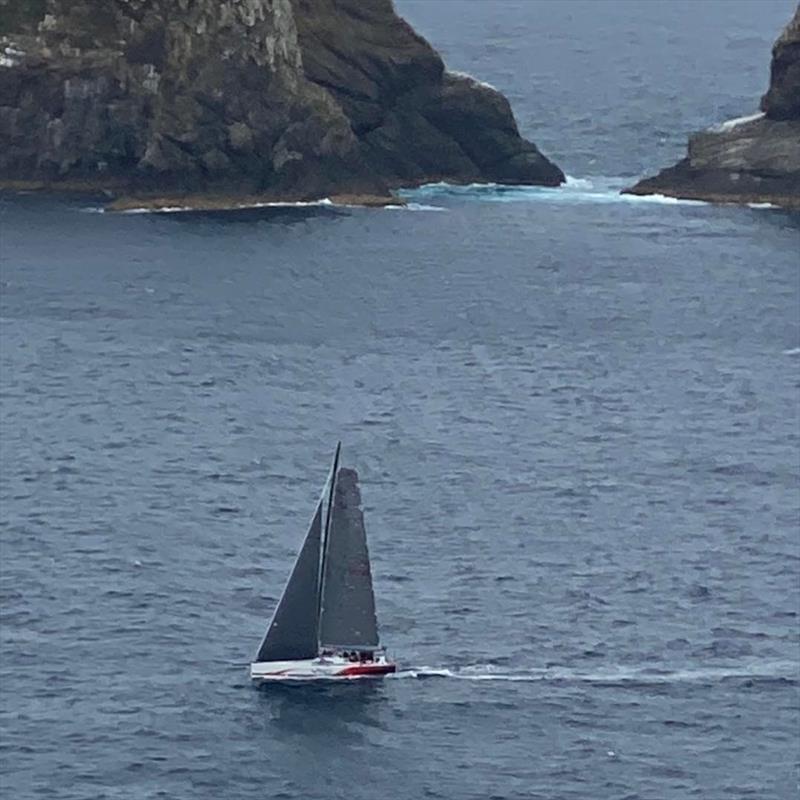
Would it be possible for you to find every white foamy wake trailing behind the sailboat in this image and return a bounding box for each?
[390,661,800,686]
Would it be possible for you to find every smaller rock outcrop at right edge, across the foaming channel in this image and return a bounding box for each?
[627,6,800,208]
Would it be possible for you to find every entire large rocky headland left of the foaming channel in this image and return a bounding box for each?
[0,0,564,206]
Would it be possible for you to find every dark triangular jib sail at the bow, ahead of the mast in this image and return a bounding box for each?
[256,500,323,661]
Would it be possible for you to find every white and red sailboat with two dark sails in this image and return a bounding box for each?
[250,442,397,681]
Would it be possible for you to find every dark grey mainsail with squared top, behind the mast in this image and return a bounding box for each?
[319,467,378,649]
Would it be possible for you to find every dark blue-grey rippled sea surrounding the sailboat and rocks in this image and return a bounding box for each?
[0,0,800,800]
